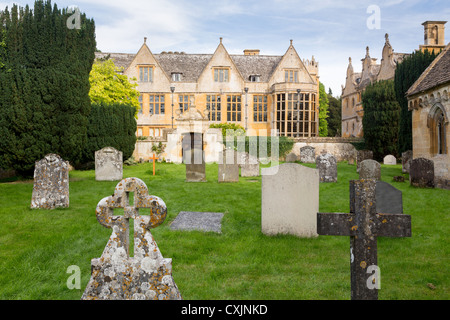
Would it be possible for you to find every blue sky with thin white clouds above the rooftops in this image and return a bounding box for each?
[0,0,450,96]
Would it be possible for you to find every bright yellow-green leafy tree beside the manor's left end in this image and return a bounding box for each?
[89,59,140,118]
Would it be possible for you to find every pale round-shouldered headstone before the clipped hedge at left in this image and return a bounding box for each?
[95,147,123,181]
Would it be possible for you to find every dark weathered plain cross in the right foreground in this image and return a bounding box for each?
[317,179,411,300]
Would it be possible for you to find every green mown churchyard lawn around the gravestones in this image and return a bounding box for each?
[0,162,450,300]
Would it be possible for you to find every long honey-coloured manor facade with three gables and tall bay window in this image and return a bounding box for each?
[96,38,319,137]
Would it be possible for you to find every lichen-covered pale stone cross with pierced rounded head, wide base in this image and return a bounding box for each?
[82,178,181,300]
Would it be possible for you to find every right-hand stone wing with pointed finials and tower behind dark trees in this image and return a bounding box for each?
[341,21,446,137]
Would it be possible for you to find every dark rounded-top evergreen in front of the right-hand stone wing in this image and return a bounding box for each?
[362,80,400,160]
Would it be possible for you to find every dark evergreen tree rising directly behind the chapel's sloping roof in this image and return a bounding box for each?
[394,50,436,154]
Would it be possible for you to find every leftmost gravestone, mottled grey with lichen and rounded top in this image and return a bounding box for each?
[31,153,69,209]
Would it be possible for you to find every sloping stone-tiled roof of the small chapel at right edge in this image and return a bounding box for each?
[406,43,450,96]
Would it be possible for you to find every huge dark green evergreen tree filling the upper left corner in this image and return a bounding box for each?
[0,1,96,175]
